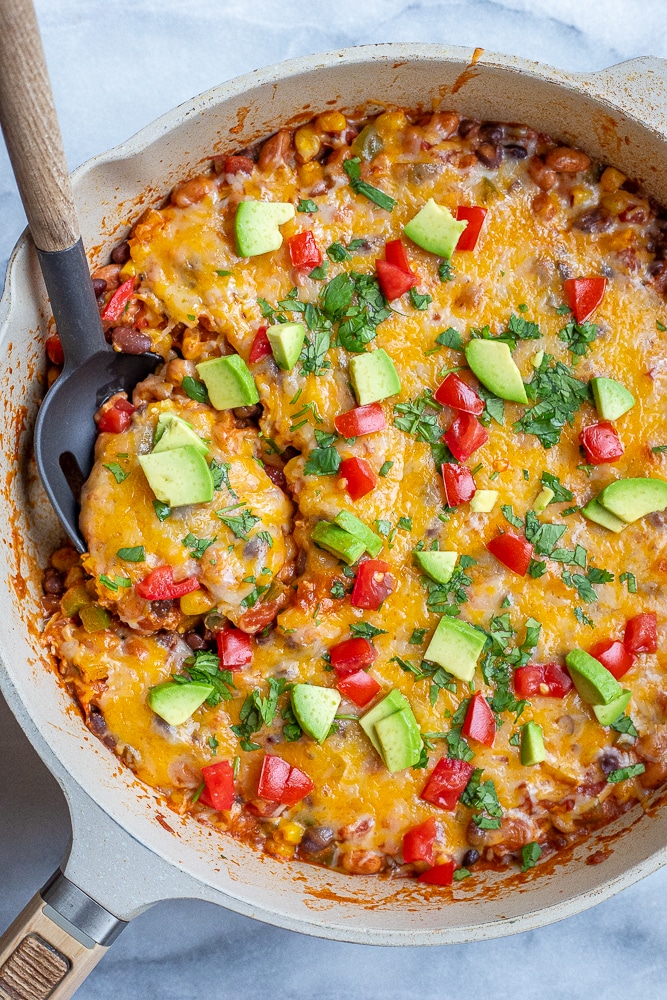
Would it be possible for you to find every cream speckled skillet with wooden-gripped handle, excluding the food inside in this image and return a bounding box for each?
[0,29,667,1000]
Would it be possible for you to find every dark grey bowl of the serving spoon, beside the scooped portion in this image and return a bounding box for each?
[35,350,163,552]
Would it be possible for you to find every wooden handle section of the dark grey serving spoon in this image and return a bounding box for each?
[0,0,79,251]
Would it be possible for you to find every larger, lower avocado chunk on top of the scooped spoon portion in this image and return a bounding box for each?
[139,445,213,507]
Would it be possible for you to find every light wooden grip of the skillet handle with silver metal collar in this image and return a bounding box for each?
[0,871,126,1000]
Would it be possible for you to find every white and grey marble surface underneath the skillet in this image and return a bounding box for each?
[0,0,667,1000]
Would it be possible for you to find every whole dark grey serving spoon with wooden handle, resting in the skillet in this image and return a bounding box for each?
[0,0,162,552]
